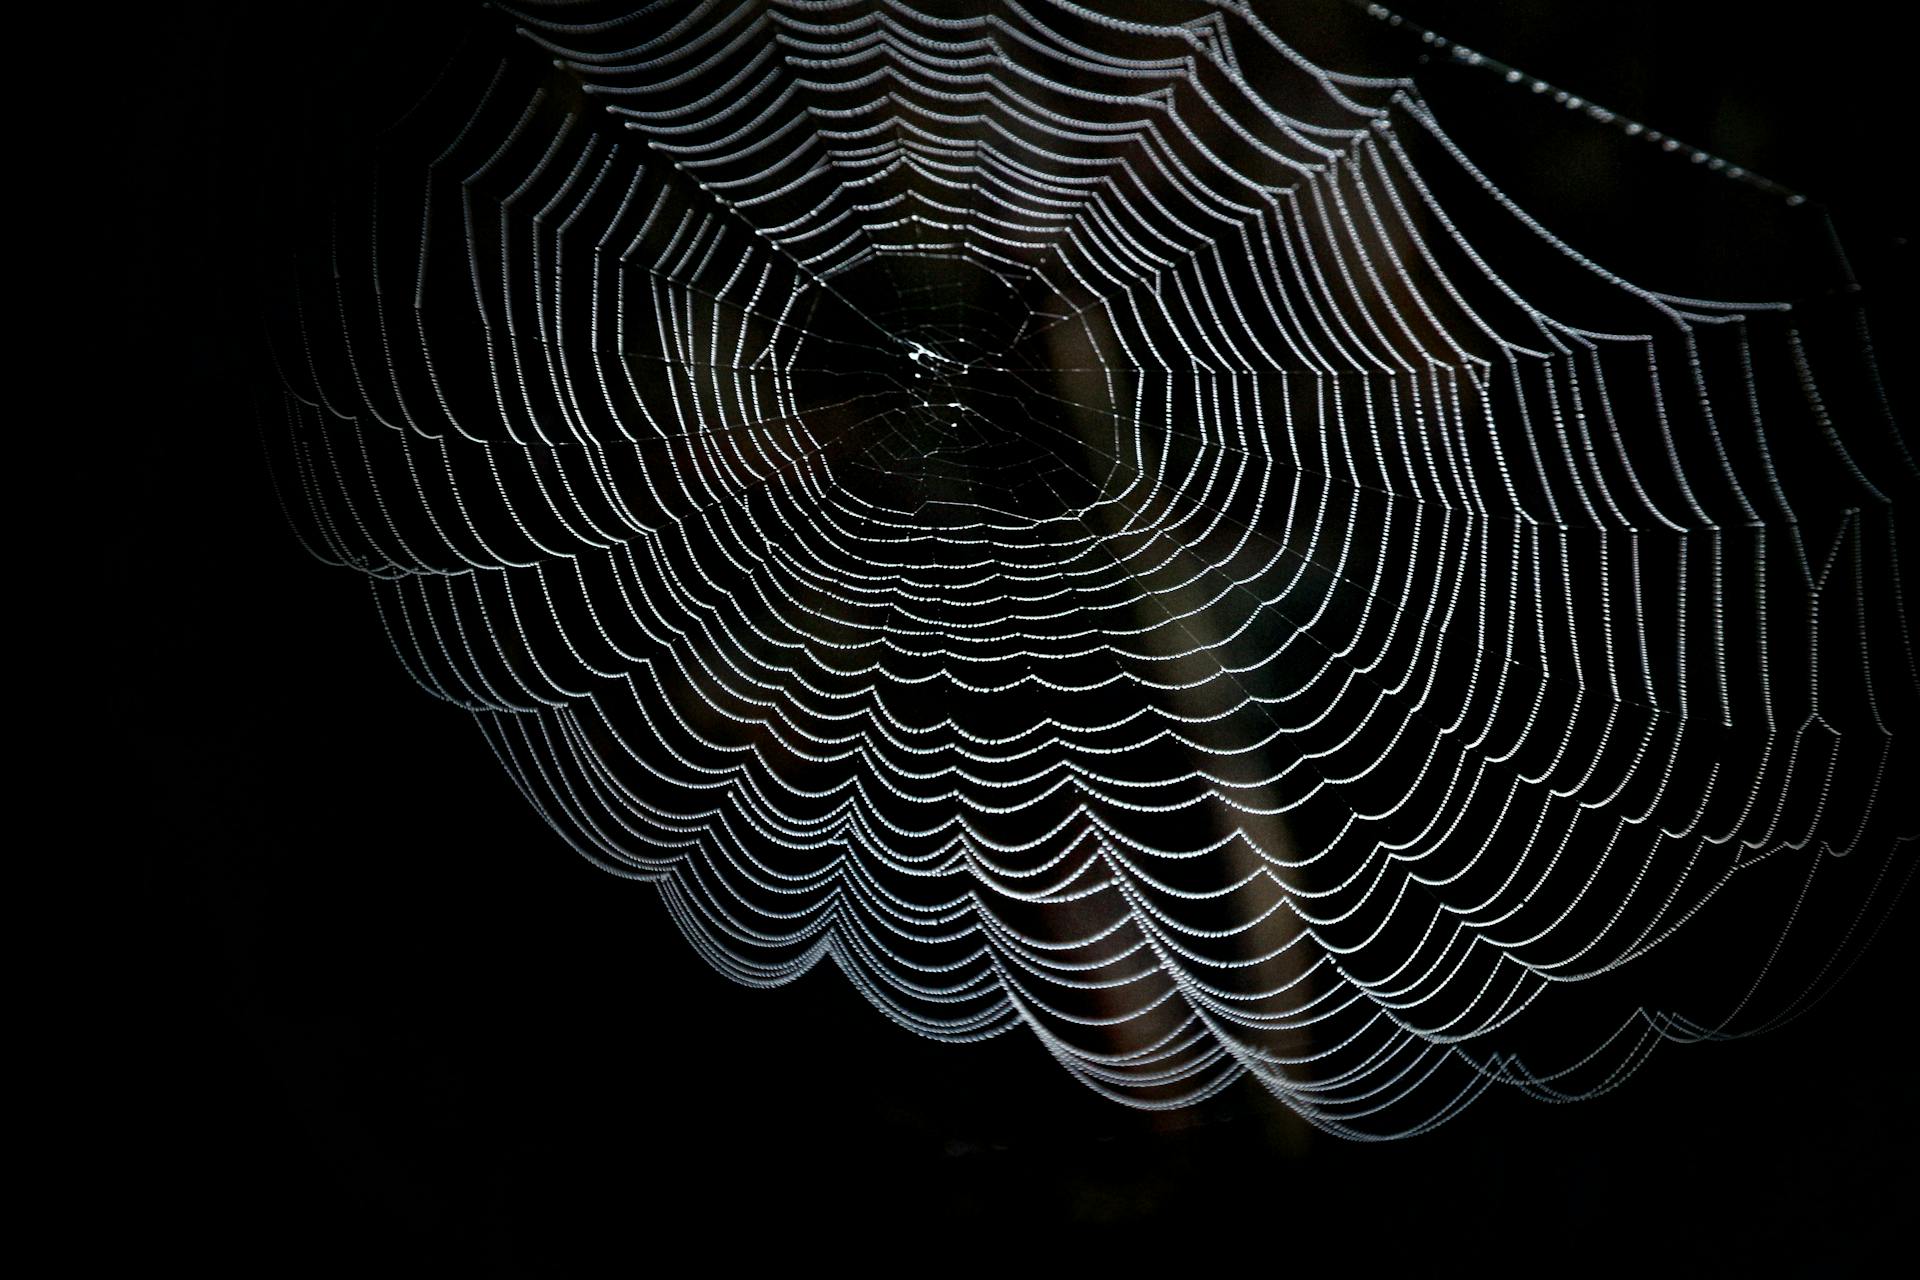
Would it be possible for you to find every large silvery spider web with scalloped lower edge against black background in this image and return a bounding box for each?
[269,0,1920,1136]
